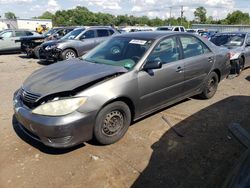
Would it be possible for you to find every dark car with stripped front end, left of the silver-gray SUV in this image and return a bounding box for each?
[17,27,76,57]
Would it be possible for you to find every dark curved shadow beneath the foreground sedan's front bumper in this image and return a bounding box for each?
[12,116,84,155]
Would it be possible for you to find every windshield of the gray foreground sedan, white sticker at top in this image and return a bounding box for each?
[82,37,153,69]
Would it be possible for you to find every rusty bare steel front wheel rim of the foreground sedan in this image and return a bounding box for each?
[102,110,124,136]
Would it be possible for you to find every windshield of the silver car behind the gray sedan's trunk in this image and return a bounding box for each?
[210,34,246,46]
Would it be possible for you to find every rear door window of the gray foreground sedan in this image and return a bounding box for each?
[180,36,211,58]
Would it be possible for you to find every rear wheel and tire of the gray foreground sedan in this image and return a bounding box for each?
[200,72,219,99]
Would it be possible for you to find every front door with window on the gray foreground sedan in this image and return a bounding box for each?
[138,37,184,114]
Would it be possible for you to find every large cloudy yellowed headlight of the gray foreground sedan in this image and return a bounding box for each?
[32,97,87,116]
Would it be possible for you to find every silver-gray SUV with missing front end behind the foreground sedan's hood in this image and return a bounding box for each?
[39,26,120,62]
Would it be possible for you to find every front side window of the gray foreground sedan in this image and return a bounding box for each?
[148,37,180,64]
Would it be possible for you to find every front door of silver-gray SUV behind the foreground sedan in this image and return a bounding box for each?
[79,29,96,56]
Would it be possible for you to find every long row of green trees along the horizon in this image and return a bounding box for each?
[38,6,250,28]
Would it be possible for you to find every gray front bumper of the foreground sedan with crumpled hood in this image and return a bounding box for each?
[14,94,95,148]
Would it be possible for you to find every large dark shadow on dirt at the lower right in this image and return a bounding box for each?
[132,96,250,188]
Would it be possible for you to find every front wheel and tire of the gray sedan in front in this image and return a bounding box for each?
[94,101,131,145]
